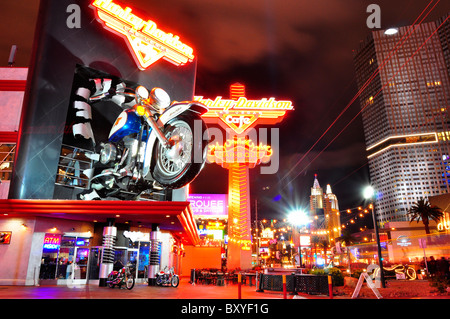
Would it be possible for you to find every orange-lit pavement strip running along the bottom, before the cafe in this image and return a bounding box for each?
[0,278,450,301]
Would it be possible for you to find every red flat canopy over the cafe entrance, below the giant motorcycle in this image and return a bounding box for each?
[0,199,200,245]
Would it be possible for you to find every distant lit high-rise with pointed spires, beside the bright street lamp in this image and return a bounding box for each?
[310,174,341,242]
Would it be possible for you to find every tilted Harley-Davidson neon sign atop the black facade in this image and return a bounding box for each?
[91,0,194,70]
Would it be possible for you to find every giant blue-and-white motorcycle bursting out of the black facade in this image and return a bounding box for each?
[79,86,209,200]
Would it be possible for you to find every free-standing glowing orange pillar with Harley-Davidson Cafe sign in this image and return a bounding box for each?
[194,83,293,269]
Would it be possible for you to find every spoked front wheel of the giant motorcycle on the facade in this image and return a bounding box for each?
[152,113,208,188]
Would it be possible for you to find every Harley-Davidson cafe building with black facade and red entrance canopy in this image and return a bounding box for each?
[0,0,206,286]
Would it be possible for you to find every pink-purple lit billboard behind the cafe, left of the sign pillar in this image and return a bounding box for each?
[188,194,228,219]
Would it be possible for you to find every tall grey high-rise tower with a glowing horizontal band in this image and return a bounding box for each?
[354,17,450,223]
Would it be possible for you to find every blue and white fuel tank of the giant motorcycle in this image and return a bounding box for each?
[109,109,151,143]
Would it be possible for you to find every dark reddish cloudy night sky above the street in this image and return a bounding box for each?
[0,0,450,224]
